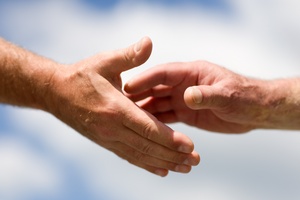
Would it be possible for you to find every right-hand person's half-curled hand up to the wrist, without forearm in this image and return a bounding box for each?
[124,61,268,133]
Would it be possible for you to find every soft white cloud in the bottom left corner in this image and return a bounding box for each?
[0,138,62,200]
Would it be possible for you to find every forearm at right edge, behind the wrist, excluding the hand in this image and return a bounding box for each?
[255,78,300,130]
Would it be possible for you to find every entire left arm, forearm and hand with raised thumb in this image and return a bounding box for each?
[0,38,200,176]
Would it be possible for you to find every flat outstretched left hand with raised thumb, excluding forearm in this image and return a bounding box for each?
[47,38,200,176]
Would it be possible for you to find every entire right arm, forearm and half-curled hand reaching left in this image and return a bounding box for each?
[125,61,300,133]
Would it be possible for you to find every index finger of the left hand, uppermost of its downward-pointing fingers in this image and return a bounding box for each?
[123,109,194,153]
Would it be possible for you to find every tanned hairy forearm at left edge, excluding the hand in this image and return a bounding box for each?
[0,38,57,109]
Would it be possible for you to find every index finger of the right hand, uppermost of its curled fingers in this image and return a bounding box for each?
[124,63,186,93]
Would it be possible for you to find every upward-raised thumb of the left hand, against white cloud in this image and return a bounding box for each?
[100,37,152,74]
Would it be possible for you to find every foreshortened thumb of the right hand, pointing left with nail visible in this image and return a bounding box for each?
[184,85,226,110]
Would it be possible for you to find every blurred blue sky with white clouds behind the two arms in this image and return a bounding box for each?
[0,0,300,200]
